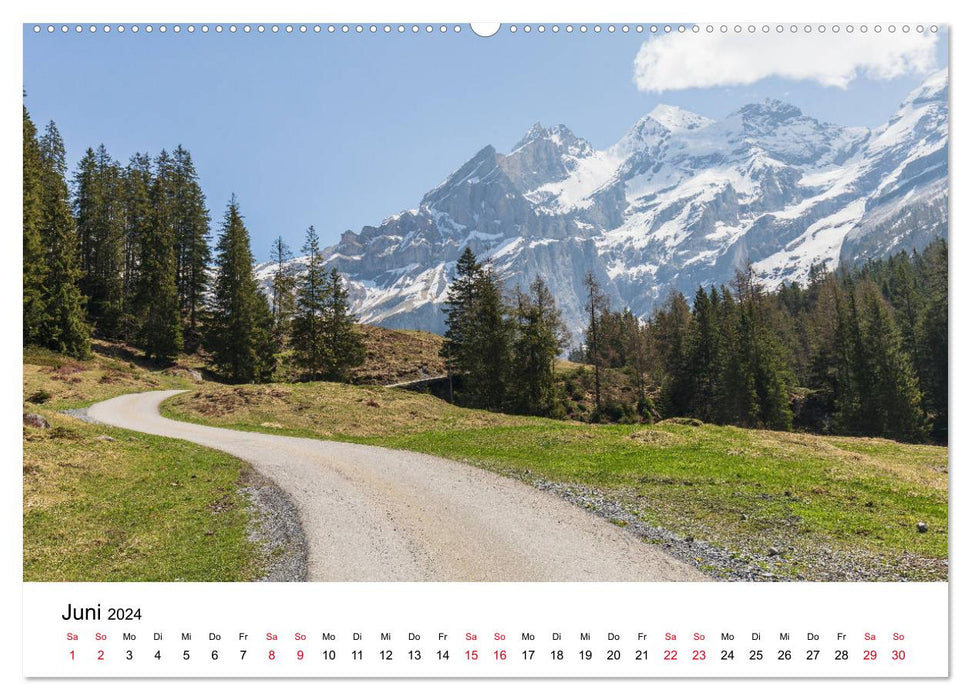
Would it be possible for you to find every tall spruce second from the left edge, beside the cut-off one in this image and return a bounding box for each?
[38,122,90,357]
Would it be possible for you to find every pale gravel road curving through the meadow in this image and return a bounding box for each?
[87,391,705,581]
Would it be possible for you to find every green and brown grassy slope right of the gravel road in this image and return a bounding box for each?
[165,383,947,579]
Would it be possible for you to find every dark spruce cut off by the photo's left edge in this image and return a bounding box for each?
[23,106,47,345]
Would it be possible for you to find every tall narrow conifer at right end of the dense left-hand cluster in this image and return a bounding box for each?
[172,144,212,351]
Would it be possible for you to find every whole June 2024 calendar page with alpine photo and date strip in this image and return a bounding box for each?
[21,7,950,688]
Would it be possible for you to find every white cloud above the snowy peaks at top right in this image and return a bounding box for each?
[634,31,937,92]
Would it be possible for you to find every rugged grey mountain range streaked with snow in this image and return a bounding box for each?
[258,70,948,340]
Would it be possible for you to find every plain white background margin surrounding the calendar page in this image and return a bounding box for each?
[0,0,971,698]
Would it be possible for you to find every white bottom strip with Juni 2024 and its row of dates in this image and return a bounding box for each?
[24,583,948,677]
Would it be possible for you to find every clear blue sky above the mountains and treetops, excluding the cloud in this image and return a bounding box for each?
[24,27,947,260]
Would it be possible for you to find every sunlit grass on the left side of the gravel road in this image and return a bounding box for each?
[23,346,261,581]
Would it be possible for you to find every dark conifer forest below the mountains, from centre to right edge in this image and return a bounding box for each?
[442,240,947,442]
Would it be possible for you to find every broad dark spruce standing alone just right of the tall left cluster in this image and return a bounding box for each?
[205,196,275,382]
